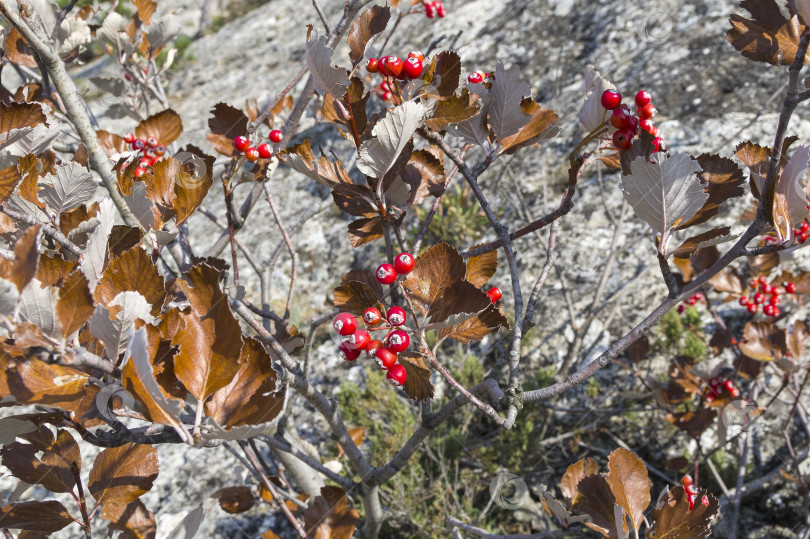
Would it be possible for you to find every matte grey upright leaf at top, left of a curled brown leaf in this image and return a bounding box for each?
[489,62,532,140]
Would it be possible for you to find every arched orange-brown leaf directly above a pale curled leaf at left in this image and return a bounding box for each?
[93,245,166,316]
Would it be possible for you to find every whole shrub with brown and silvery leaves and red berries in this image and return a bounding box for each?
[0,0,810,539]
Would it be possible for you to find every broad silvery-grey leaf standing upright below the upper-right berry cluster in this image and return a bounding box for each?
[621,152,709,253]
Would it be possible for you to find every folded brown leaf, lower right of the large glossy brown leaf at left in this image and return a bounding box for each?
[205,337,285,428]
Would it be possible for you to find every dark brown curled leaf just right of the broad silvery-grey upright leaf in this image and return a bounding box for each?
[676,153,745,230]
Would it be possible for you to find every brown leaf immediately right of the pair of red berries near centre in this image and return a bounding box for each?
[403,242,467,314]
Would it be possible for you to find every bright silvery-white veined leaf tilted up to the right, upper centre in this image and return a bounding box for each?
[357,101,425,178]
